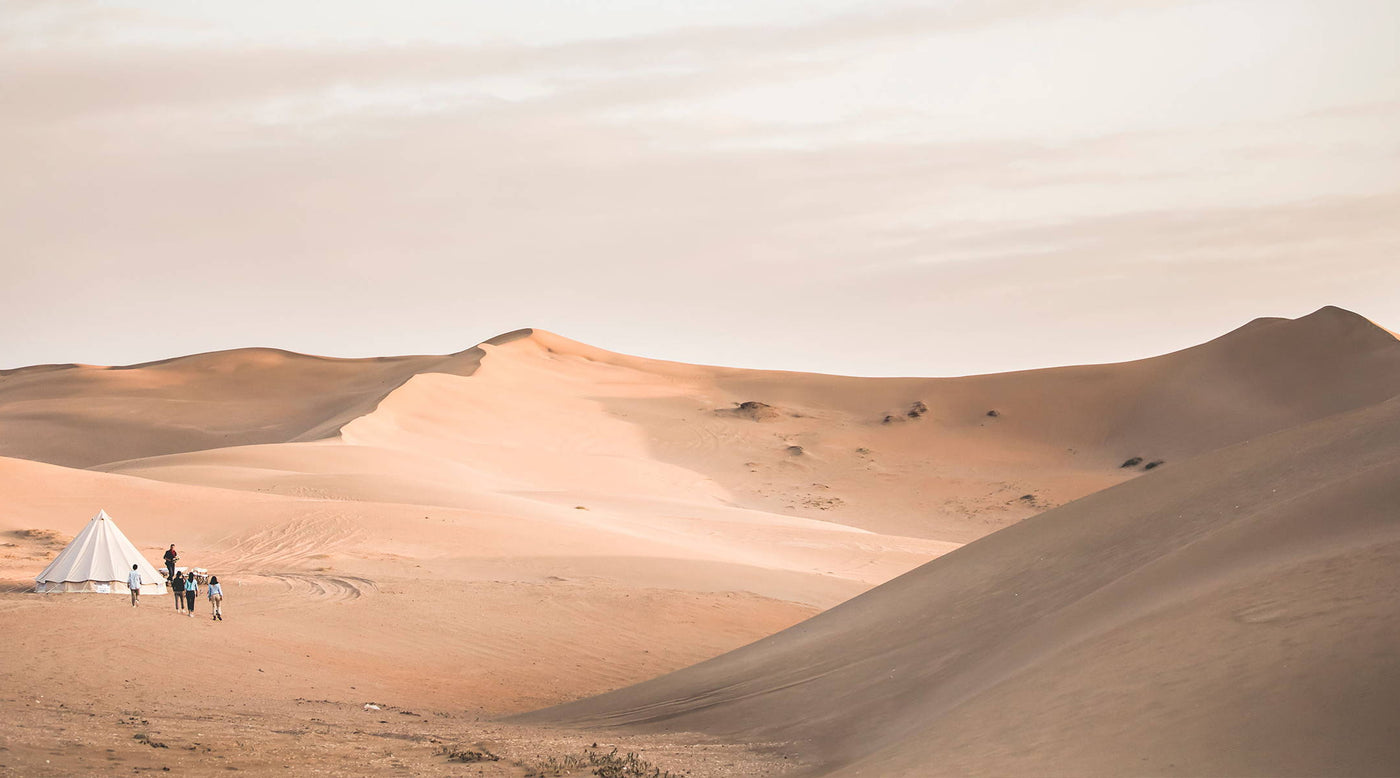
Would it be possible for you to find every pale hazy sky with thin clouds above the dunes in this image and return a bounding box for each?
[0,0,1400,375]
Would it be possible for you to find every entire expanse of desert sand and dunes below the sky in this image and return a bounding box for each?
[0,308,1400,775]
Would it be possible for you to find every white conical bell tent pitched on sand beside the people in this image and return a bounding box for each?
[34,511,165,595]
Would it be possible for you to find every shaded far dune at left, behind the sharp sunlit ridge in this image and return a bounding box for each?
[0,336,518,467]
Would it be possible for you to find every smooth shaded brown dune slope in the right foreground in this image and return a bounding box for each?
[532,391,1400,775]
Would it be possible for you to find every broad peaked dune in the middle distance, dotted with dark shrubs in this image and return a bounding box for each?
[73,308,1400,543]
